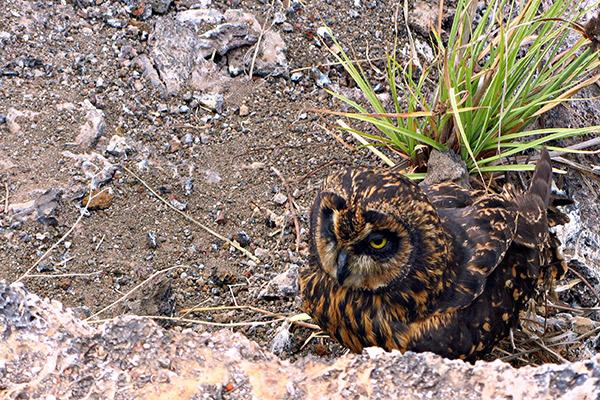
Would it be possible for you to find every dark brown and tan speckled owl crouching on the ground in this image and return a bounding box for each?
[300,149,566,360]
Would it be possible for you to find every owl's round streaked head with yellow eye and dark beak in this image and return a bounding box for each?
[311,169,446,291]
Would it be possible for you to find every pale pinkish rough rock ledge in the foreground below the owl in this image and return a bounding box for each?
[0,283,600,400]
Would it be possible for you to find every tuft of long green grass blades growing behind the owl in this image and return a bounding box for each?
[328,0,600,173]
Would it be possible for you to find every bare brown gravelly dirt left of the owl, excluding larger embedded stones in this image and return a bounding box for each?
[0,0,598,357]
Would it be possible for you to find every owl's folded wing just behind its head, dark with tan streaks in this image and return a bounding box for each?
[436,195,519,312]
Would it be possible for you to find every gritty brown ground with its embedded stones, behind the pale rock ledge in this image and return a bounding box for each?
[0,0,600,386]
